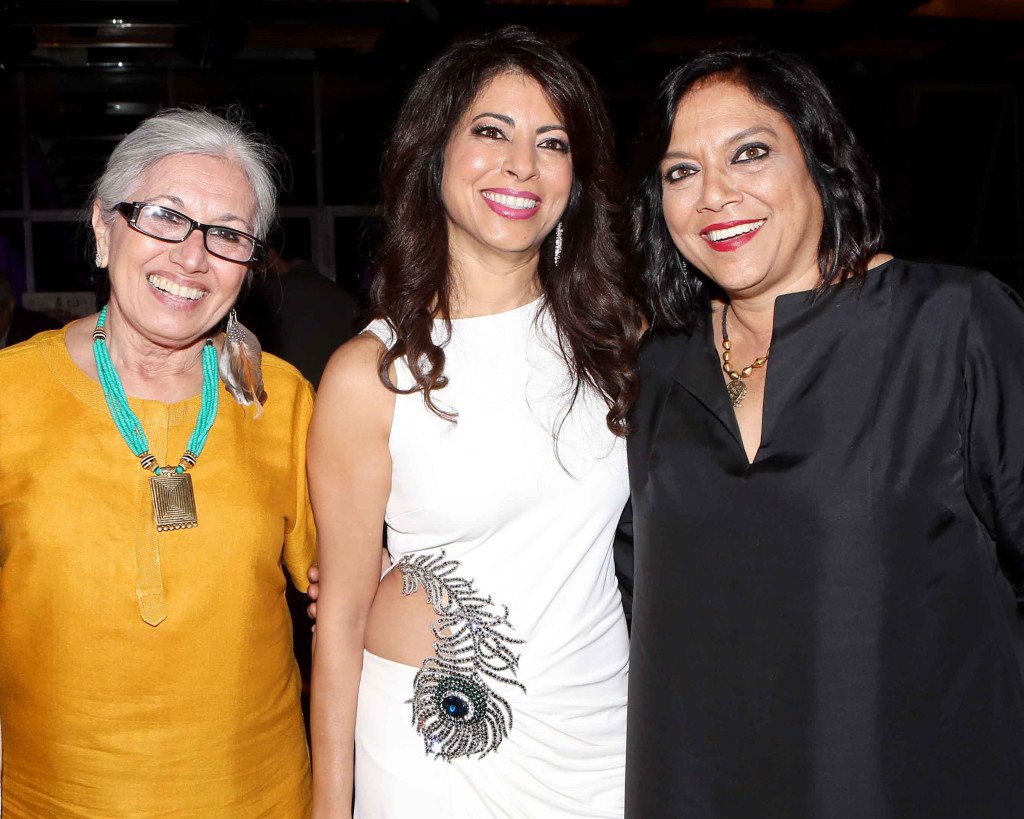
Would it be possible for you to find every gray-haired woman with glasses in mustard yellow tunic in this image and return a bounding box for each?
[0,110,315,817]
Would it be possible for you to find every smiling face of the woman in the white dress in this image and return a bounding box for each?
[441,73,572,266]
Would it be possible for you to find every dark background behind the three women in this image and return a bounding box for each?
[0,0,1024,708]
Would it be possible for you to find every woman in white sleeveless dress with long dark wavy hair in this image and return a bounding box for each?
[309,28,641,819]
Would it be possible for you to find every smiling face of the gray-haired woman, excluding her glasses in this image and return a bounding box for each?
[92,155,255,348]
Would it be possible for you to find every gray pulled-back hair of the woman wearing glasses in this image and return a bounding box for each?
[89,107,280,239]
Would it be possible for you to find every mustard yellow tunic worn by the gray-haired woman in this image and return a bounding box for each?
[0,331,315,819]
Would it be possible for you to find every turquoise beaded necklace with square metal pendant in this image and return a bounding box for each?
[92,305,219,531]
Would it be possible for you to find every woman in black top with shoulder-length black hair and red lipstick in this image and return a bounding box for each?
[625,50,1024,819]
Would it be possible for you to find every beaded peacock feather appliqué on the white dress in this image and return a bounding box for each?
[398,552,526,762]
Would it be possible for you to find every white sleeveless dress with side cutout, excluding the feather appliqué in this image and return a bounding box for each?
[355,298,629,819]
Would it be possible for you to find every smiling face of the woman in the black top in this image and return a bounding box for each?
[660,78,823,298]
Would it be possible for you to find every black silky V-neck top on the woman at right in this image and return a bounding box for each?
[617,260,1024,819]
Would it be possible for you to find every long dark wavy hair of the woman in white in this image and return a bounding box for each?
[370,26,641,435]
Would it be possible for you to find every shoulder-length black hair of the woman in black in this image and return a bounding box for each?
[628,47,883,331]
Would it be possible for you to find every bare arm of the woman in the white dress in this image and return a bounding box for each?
[308,334,394,819]
